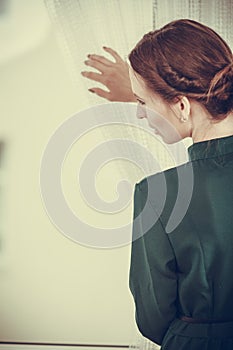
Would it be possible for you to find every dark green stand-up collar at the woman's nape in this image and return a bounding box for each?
[188,135,233,161]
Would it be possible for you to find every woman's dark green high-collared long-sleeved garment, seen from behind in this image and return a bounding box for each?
[129,135,233,350]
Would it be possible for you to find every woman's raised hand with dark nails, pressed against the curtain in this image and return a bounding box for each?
[81,47,136,102]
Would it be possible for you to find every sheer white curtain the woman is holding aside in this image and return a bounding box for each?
[45,0,233,349]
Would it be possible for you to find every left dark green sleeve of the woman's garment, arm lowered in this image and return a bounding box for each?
[129,181,177,345]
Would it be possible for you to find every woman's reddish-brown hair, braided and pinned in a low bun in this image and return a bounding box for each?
[129,19,233,119]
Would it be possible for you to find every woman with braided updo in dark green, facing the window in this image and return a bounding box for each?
[82,20,233,350]
